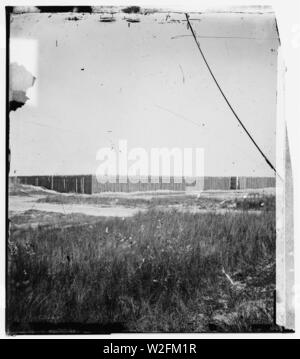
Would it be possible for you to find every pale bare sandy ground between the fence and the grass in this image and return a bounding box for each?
[8,185,275,221]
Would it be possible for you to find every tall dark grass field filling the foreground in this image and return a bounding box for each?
[7,204,276,333]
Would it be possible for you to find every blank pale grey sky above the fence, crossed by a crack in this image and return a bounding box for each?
[10,13,278,176]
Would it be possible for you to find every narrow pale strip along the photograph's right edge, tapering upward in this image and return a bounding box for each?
[276,50,295,330]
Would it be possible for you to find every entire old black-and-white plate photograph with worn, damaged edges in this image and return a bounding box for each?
[6,4,294,335]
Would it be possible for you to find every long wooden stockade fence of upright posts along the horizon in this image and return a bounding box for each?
[9,175,276,194]
